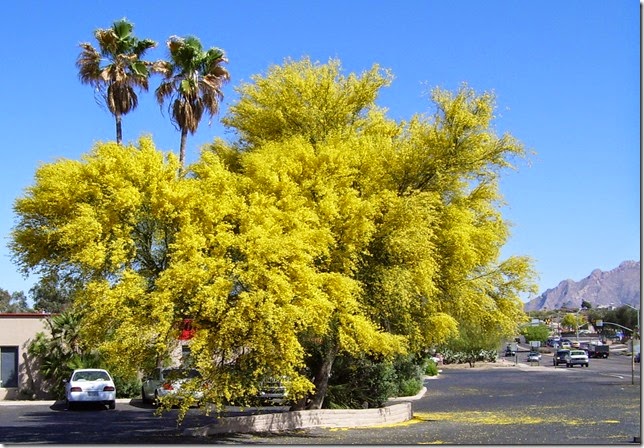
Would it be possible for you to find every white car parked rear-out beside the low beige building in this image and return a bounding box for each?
[64,369,116,409]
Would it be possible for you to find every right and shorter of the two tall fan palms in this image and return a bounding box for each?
[156,36,230,164]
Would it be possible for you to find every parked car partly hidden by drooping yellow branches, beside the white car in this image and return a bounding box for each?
[141,367,203,404]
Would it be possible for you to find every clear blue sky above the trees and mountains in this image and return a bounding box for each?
[0,0,641,299]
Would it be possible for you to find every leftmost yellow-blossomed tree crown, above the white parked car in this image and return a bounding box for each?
[11,138,189,374]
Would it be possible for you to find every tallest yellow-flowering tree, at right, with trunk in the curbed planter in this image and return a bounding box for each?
[213,58,533,408]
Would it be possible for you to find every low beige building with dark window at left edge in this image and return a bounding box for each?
[0,313,51,400]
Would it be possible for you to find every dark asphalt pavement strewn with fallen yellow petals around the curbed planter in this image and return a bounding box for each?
[0,356,641,445]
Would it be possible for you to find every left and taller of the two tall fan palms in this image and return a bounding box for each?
[76,19,157,144]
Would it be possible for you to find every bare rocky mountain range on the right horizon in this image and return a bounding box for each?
[524,261,641,311]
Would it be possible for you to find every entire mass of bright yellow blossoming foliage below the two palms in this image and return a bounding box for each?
[11,59,533,418]
